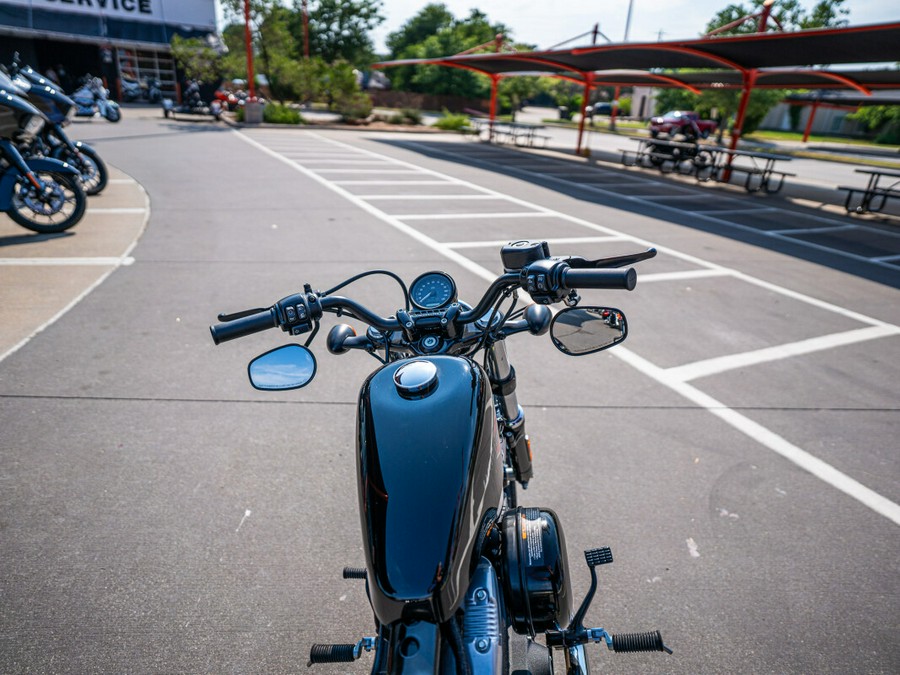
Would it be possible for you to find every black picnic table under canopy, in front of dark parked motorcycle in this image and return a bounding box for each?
[620,136,795,193]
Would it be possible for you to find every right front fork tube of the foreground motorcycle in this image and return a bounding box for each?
[487,340,534,488]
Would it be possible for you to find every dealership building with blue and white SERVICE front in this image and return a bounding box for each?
[0,0,216,98]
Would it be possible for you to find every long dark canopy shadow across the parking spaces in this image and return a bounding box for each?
[378,139,900,288]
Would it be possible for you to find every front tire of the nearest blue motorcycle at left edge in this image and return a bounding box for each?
[6,171,87,234]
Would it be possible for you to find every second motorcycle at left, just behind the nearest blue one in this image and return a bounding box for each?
[9,54,109,195]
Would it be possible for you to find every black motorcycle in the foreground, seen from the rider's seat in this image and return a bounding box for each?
[210,241,671,675]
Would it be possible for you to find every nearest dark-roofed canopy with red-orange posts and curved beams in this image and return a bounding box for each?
[375,22,900,152]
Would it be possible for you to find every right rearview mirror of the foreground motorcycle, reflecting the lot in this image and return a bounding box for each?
[550,307,628,356]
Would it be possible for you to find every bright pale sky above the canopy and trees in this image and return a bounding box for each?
[372,0,900,53]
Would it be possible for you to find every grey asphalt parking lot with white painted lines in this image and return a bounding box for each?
[0,112,900,673]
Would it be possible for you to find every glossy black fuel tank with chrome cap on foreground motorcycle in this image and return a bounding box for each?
[357,356,503,624]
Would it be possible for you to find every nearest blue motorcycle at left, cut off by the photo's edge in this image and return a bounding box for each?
[0,69,87,234]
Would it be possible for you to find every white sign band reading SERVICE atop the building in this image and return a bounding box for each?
[0,0,216,31]
